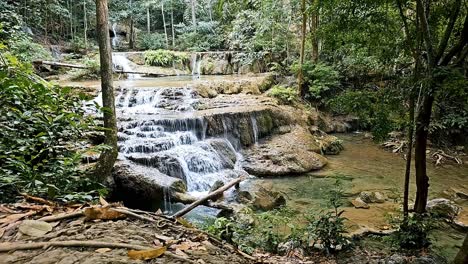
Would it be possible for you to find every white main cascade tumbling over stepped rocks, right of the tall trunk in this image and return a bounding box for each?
[116,85,245,197]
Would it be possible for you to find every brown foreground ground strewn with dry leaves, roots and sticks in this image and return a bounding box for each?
[0,196,454,264]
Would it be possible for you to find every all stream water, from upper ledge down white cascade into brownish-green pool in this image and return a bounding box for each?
[66,53,468,258]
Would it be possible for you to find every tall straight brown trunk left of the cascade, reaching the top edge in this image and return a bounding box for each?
[94,0,118,182]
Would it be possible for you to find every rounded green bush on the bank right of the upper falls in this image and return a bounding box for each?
[291,62,341,105]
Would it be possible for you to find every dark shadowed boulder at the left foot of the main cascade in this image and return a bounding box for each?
[111,162,186,209]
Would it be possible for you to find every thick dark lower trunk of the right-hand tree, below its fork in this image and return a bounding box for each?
[414,92,434,213]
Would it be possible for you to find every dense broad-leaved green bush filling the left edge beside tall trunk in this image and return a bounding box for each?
[0,57,102,201]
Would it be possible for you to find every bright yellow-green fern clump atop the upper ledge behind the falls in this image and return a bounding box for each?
[145,50,189,67]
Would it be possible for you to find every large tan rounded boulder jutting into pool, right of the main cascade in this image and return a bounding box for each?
[243,127,327,177]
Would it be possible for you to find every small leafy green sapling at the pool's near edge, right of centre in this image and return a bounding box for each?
[307,177,348,254]
